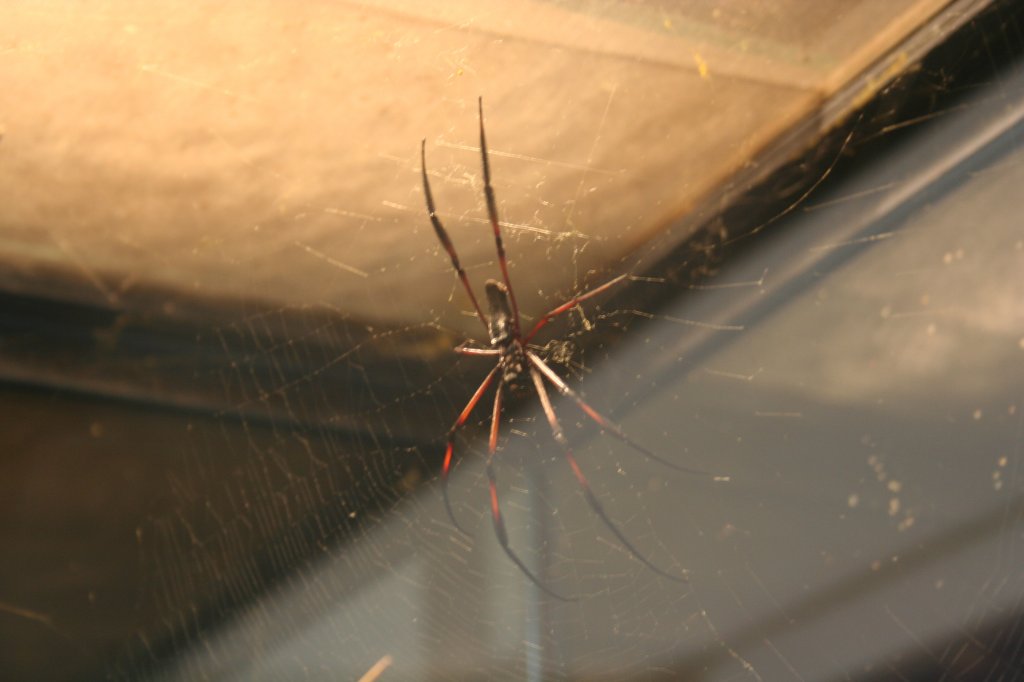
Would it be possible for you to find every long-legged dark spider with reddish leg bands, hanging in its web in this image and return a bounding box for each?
[420,97,708,601]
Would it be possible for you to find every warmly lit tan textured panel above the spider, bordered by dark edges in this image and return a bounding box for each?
[0,0,944,327]
